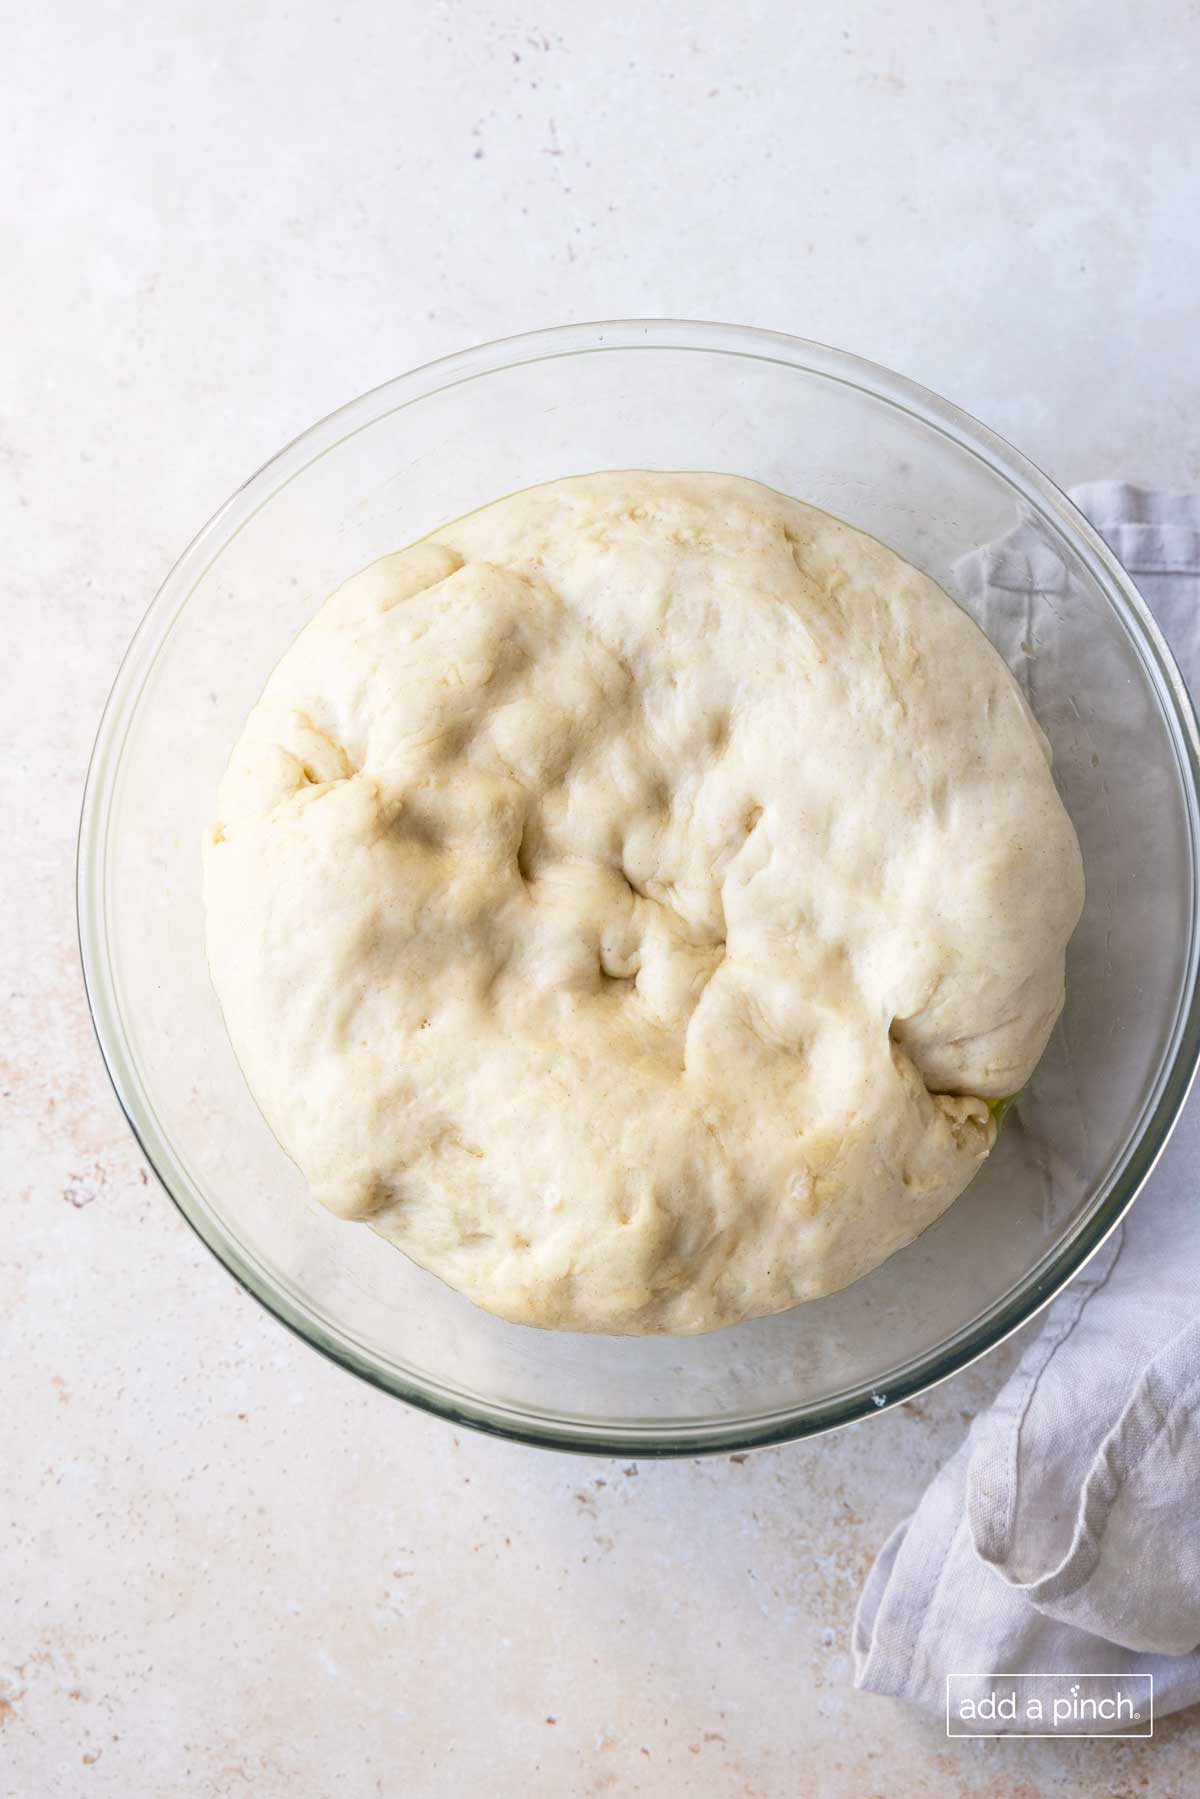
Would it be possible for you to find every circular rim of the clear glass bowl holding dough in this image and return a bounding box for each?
[76,318,1200,1459]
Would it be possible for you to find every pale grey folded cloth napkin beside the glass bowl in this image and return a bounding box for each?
[853,482,1200,1729]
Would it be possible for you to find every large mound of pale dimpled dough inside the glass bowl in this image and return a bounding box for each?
[205,473,1083,1333]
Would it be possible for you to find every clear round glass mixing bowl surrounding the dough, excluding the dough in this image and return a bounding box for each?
[79,322,1200,1455]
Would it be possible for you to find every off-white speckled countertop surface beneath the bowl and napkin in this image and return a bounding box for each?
[0,0,1200,1799]
